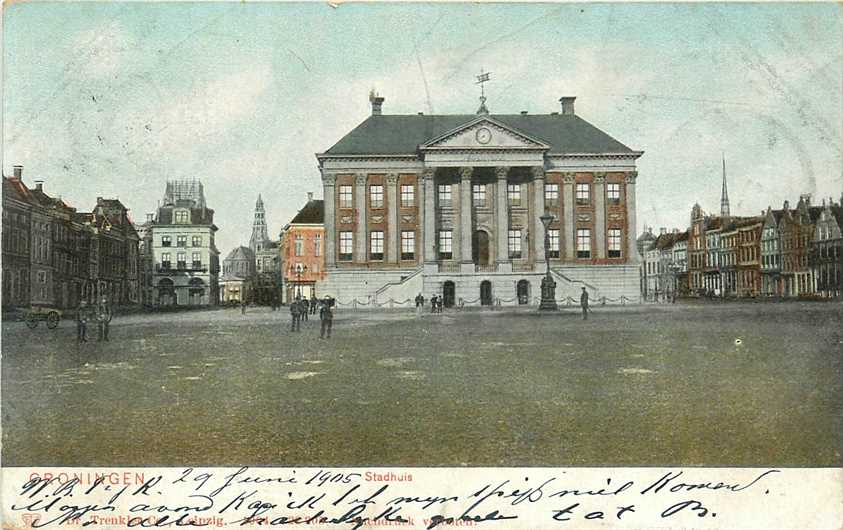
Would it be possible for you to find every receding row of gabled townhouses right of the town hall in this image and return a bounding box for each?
[638,191,843,300]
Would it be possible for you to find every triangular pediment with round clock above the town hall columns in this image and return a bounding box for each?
[420,116,549,150]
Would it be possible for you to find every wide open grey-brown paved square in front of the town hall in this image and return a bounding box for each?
[2,303,843,466]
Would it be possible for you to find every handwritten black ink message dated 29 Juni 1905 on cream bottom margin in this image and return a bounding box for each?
[3,467,816,530]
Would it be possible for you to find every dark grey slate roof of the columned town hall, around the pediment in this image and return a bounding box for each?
[324,114,633,155]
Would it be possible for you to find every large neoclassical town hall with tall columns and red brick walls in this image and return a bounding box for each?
[317,93,642,304]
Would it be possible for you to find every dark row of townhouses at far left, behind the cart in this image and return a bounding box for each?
[2,166,139,310]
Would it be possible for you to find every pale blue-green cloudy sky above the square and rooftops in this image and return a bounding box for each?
[2,2,843,254]
